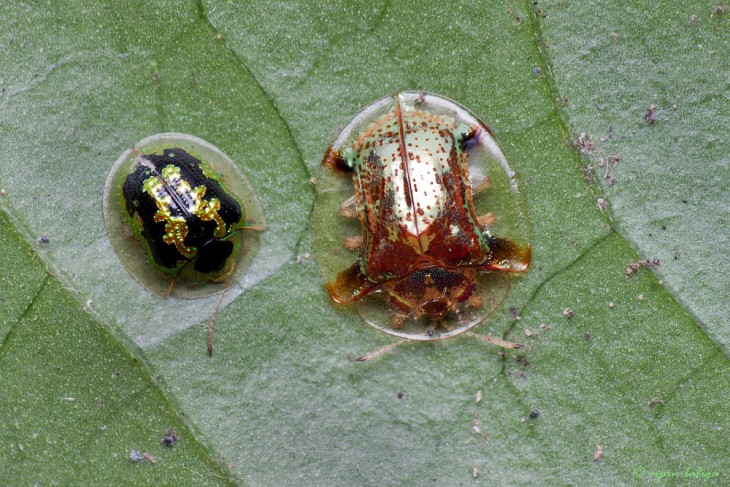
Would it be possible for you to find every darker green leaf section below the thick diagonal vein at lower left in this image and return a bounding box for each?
[0,213,225,485]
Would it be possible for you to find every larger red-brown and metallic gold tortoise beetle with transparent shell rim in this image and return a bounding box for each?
[312,92,531,352]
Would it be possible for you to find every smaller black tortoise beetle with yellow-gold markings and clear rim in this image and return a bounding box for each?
[104,133,265,298]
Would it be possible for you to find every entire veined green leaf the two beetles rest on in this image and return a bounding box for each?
[0,0,730,485]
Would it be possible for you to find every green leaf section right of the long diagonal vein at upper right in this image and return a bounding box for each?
[539,2,730,352]
